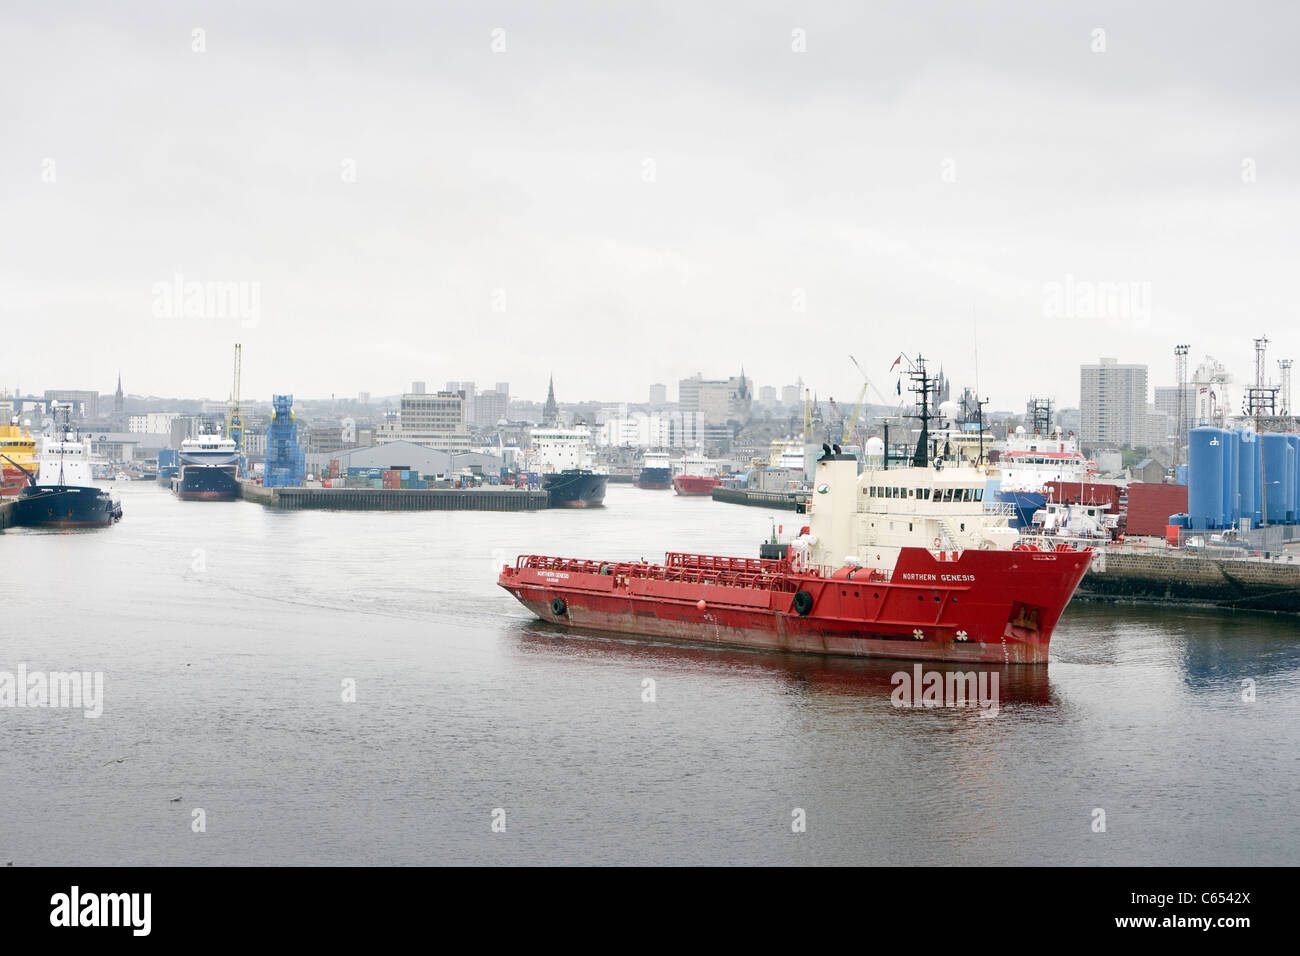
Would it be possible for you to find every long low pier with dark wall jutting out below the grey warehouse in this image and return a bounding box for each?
[239,481,550,511]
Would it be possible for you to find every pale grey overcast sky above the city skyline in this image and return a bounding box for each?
[0,0,1300,408]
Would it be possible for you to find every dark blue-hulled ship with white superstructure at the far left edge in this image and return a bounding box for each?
[5,402,122,528]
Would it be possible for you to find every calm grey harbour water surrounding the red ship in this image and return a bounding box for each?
[0,483,1300,866]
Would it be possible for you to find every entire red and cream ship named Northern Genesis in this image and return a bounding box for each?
[497,356,1093,665]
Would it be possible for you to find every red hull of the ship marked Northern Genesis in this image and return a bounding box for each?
[498,549,1092,665]
